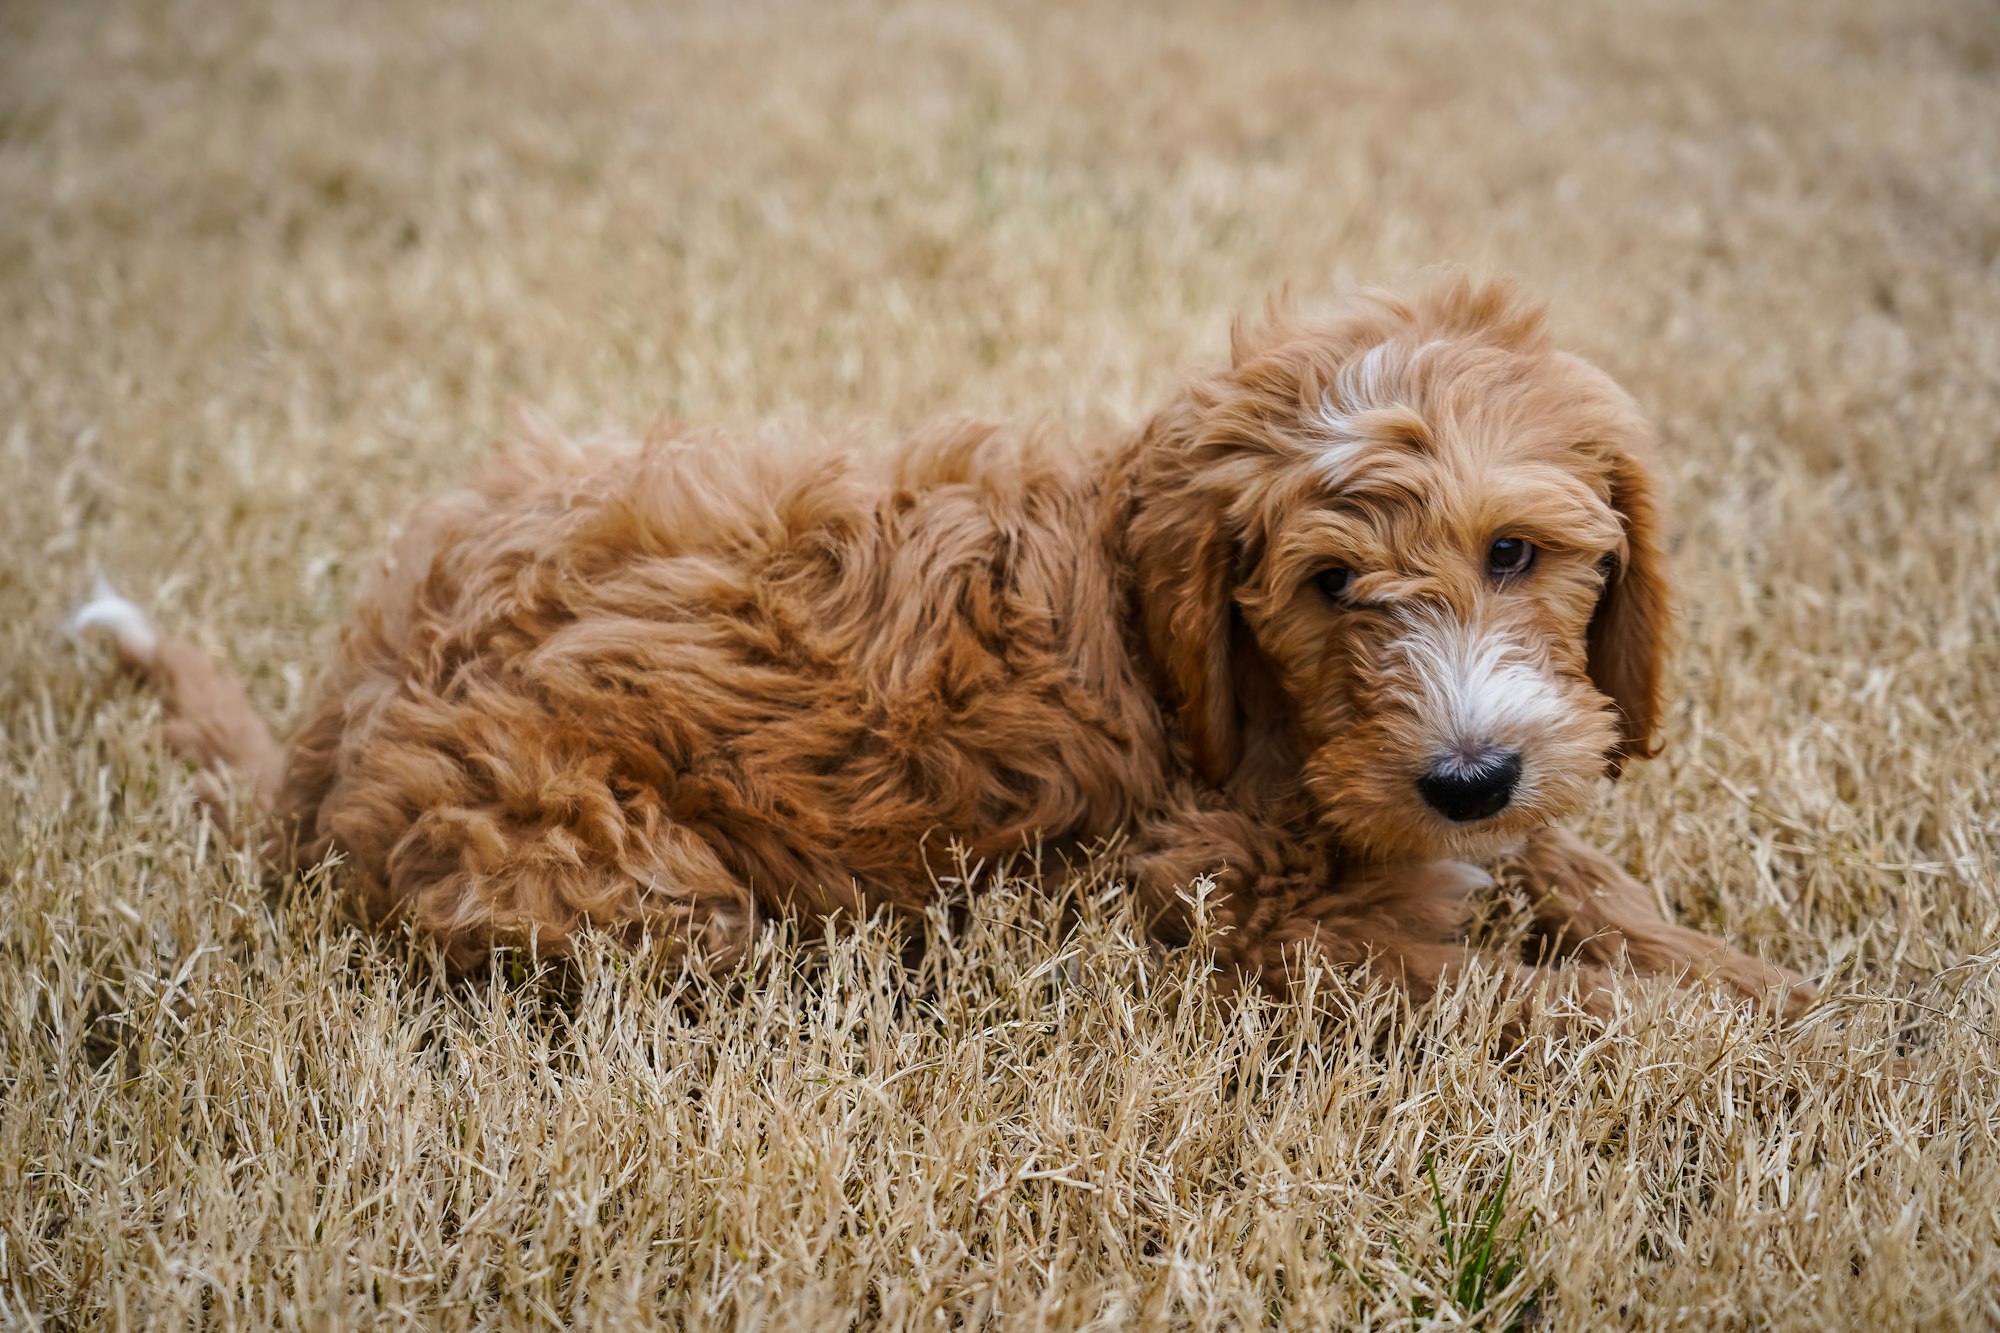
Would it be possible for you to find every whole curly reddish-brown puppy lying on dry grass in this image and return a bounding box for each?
[78,276,1810,1015]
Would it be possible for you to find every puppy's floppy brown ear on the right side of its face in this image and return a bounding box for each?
[1588,444,1670,777]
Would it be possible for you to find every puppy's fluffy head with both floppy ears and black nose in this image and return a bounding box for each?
[1126,276,1668,857]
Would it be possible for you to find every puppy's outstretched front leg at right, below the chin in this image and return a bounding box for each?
[1518,827,1814,1019]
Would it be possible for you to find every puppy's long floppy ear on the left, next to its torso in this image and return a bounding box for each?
[1126,412,1242,787]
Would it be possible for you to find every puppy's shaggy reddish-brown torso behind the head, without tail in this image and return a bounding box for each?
[276,426,1192,961]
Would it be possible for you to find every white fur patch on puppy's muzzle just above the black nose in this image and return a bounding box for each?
[1394,612,1562,751]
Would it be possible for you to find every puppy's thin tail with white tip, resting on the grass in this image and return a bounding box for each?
[70,578,284,827]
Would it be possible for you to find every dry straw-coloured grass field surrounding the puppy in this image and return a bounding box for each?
[0,0,2000,1329]
